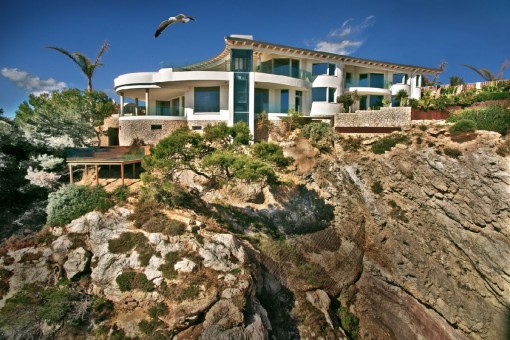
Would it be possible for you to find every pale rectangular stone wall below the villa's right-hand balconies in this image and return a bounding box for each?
[335,107,411,127]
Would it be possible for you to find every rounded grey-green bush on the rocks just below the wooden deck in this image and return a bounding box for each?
[46,184,114,225]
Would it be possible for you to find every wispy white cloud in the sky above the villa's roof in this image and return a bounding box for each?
[315,15,375,55]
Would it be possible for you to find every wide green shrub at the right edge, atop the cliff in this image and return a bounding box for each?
[446,105,510,135]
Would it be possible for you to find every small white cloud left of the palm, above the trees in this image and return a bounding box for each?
[0,67,67,95]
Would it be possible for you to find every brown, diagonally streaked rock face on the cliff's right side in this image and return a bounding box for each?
[288,129,510,339]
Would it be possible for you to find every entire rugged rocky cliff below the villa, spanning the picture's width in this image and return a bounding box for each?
[0,128,510,339]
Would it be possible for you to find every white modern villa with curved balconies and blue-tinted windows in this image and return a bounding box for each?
[114,35,440,145]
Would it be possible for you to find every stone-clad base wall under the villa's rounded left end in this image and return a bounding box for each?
[119,116,188,146]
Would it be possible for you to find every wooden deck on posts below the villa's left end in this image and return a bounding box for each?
[67,147,148,185]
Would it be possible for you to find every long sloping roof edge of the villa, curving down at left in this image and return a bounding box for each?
[178,37,442,74]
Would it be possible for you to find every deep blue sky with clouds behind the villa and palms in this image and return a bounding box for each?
[0,0,510,116]
